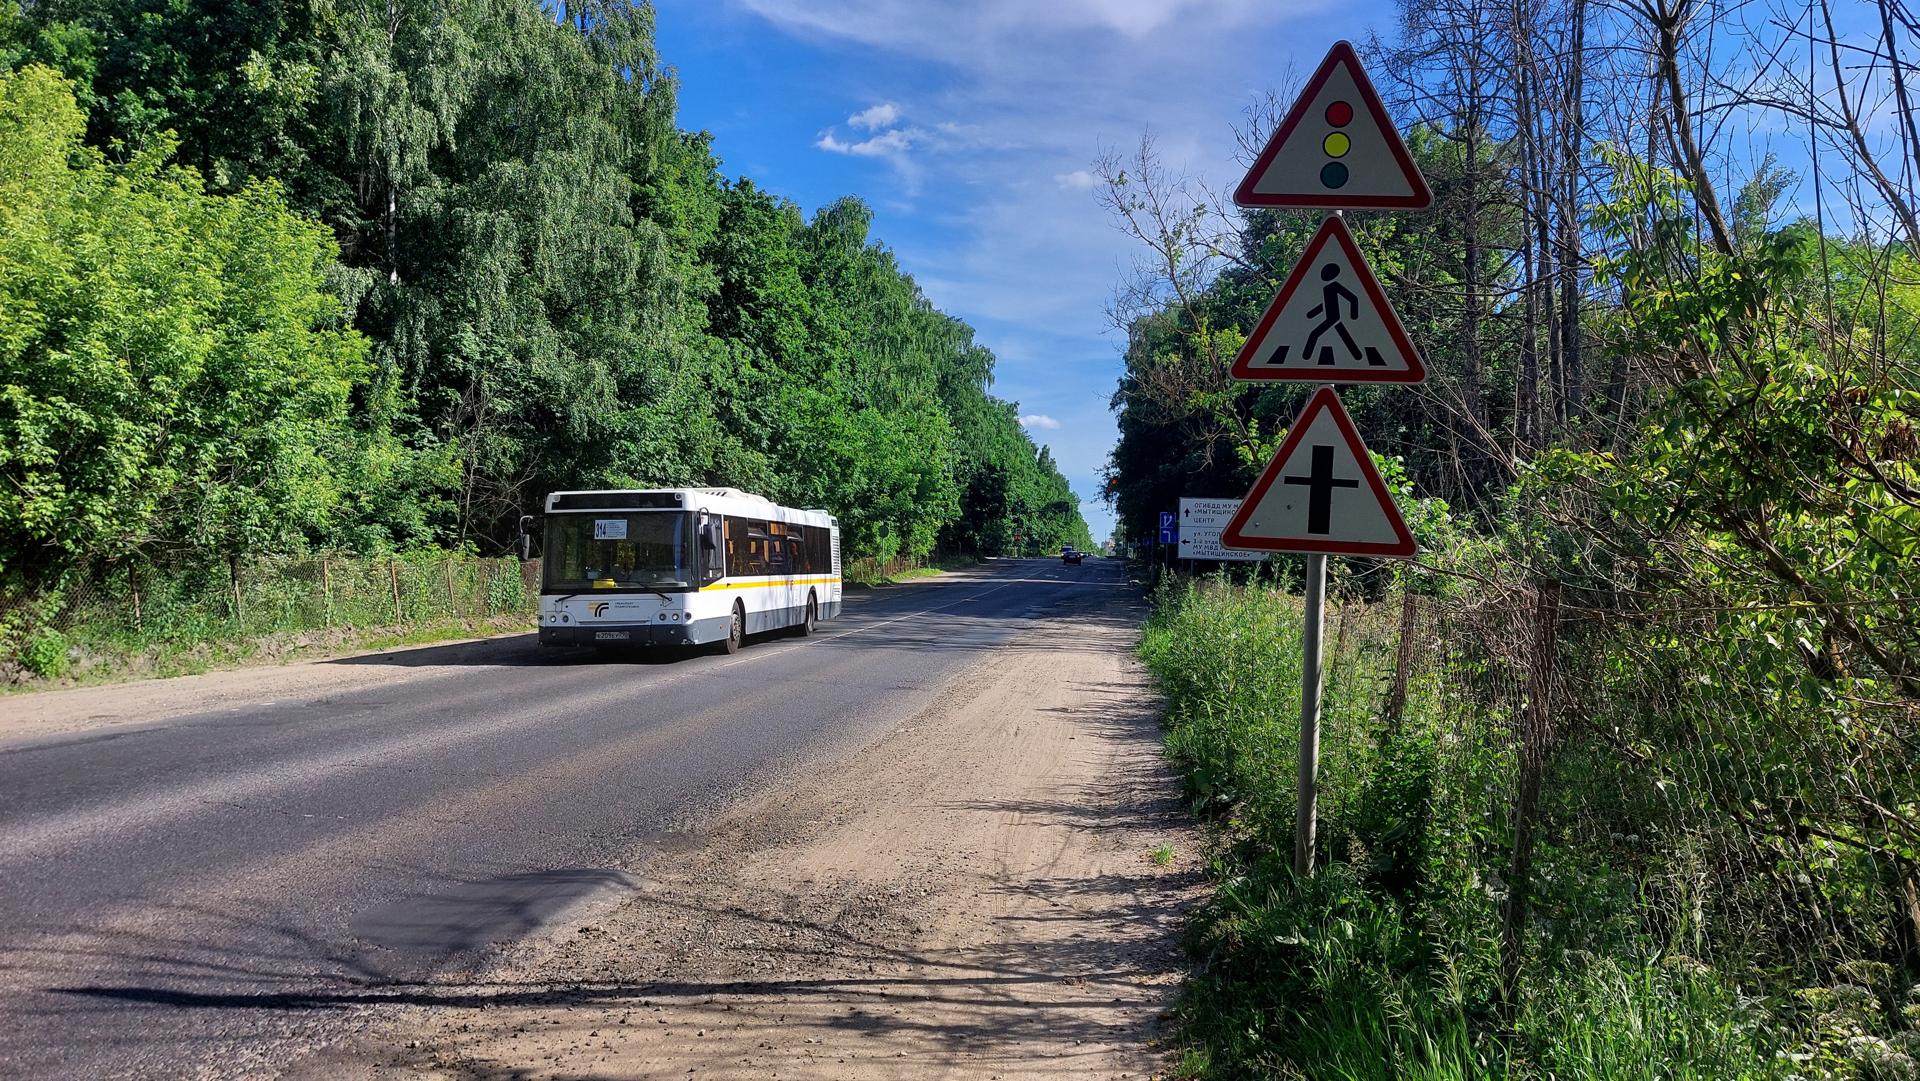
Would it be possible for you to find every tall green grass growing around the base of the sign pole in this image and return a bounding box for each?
[1140,582,1812,1081]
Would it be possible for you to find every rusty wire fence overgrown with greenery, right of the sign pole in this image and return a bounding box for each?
[1382,584,1920,998]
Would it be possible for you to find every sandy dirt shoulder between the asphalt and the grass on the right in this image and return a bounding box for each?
[292,591,1196,1081]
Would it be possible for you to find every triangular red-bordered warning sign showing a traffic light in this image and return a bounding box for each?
[1233,42,1434,209]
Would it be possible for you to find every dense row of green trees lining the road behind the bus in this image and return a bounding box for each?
[0,0,1089,584]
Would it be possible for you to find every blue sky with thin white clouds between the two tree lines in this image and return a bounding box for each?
[659,0,1394,538]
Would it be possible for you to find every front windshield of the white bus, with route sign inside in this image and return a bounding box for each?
[543,511,699,593]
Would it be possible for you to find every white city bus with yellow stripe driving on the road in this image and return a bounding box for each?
[537,488,841,653]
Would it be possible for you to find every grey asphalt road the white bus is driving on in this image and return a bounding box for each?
[0,561,1125,1079]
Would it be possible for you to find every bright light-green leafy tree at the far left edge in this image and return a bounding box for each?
[0,65,365,576]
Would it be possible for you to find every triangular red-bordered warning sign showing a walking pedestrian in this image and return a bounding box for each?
[1233,217,1427,382]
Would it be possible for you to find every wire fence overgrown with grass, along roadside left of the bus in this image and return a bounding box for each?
[0,553,540,682]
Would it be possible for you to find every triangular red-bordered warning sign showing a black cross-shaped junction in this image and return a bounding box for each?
[1219,386,1413,557]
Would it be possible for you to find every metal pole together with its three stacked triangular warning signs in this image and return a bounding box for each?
[1221,40,1432,876]
